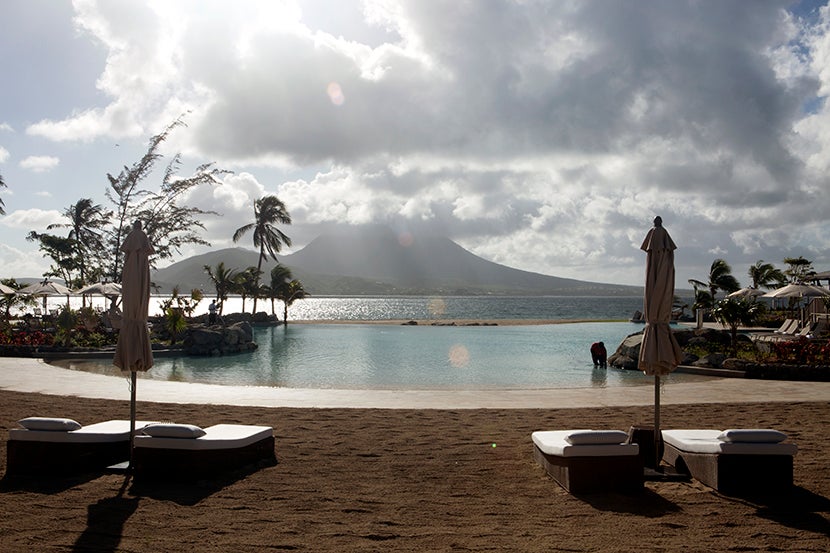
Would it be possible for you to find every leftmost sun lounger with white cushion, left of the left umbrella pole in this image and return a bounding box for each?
[6,417,156,475]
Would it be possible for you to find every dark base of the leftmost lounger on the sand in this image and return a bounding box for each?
[6,440,130,475]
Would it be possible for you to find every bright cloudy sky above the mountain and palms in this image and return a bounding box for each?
[0,0,830,288]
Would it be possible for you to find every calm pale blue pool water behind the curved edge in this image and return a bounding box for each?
[61,322,708,390]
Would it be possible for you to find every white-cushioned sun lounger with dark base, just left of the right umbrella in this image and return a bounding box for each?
[531,430,643,494]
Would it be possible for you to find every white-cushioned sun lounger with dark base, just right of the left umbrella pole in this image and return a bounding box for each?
[133,424,276,480]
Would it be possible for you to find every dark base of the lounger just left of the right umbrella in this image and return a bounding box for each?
[533,444,643,494]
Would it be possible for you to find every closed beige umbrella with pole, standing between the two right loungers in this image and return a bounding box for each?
[638,217,682,468]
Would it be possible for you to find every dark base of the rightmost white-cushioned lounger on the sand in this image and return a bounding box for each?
[663,443,793,494]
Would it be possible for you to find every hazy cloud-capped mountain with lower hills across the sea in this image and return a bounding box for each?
[153,226,642,296]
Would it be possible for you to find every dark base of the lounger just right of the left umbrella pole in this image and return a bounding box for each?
[133,436,277,480]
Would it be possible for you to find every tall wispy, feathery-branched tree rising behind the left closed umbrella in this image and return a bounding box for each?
[106,118,227,280]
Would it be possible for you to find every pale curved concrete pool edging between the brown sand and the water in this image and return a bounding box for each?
[0,357,830,409]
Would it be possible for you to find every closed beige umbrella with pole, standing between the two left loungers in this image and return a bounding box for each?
[113,221,153,468]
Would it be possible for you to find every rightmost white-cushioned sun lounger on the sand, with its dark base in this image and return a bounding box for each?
[663,429,798,494]
